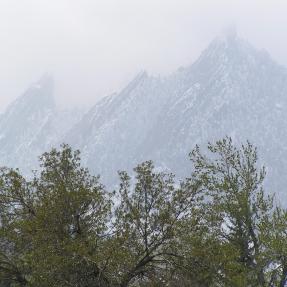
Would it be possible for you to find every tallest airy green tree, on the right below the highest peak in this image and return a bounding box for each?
[190,138,273,286]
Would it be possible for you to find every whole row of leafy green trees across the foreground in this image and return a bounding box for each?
[0,138,287,287]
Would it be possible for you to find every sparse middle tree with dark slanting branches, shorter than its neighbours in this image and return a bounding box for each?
[112,161,200,287]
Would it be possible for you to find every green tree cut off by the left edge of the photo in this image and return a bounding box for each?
[0,168,34,286]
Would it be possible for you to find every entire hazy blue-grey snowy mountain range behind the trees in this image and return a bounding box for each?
[0,33,287,203]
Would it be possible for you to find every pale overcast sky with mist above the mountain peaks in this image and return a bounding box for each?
[0,0,287,111]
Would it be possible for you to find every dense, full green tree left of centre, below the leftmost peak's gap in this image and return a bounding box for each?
[26,145,111,287]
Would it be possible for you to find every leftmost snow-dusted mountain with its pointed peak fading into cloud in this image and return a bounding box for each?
[0,75,83,174]
